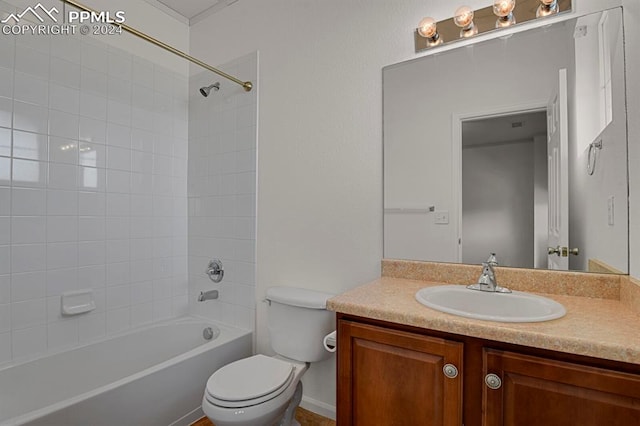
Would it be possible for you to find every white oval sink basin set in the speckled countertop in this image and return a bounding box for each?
[416,285,566,322]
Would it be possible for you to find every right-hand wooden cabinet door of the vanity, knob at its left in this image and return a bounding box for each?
[483,349,640,426]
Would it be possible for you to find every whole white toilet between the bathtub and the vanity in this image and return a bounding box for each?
[202,287,335,426]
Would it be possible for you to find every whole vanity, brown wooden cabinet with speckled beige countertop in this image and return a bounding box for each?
[328,262,640,426]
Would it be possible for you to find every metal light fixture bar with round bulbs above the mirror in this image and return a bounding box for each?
[414,0,572,53]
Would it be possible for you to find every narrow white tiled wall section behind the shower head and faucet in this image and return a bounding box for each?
[188,53,258,330]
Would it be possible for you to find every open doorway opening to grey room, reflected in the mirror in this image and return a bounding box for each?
[461,108,549,268]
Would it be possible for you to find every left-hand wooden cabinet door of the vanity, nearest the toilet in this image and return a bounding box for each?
[338,320,463,426]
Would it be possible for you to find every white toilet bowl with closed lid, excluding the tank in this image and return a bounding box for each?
[202,355,307,426]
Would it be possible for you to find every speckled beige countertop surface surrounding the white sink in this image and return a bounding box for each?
[327,276,640,364]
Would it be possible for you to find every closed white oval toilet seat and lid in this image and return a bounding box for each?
[205,355,295,408]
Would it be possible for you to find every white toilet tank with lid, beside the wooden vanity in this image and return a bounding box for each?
[266,287,336,362]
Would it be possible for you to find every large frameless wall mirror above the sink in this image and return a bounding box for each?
[383,8,629,273]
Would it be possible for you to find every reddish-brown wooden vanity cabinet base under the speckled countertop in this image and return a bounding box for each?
[337,314,640,426]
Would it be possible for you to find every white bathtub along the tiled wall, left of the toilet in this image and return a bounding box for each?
[0,318,252,426]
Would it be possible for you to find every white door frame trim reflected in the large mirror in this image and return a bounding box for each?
[451,99,548,263]
